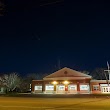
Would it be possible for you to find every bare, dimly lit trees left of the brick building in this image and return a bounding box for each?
[0,72,48,93]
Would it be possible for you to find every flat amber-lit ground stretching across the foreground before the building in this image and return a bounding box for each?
[0,97,110,110]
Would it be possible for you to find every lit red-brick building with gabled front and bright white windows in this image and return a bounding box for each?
[32,67,110,94]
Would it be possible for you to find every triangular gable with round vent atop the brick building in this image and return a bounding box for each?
[43,67,91,80]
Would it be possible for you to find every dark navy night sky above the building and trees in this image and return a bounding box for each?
[0,0,110,74]
